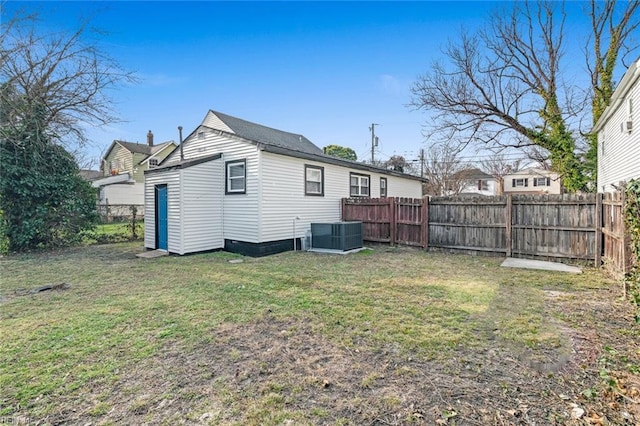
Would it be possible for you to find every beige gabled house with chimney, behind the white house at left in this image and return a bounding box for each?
[92,130,176,211]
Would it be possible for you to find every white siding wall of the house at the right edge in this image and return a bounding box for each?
[598,79,640,192]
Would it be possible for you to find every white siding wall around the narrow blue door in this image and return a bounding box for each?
[144,170,182,253]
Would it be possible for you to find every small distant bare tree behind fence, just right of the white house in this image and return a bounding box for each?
[423,142,466,195]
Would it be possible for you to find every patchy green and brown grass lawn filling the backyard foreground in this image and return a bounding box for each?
[0,242,640,425]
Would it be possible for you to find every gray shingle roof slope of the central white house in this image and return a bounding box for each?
[211,110,322,154]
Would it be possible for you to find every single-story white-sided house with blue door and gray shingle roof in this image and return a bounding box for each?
[145,111,423,256]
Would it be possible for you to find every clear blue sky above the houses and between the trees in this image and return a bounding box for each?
[4,1,608,168]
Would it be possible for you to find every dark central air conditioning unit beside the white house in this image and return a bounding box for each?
[311,222,362,251]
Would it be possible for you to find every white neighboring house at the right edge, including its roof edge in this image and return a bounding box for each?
[593,59,640,192]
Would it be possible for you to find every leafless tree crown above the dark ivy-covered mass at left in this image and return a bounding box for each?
[0,10,135,151]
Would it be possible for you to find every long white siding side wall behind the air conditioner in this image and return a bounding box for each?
[258,152,422,242]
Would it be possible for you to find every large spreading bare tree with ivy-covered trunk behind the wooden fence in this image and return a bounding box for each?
[412,1,636,191]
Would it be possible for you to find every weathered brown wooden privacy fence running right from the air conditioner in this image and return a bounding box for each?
[342,194,630,272]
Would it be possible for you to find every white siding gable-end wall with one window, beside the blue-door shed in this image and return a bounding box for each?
[167,131,260,243]
